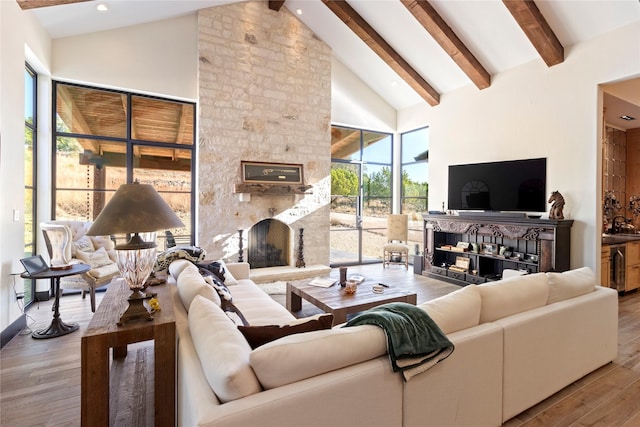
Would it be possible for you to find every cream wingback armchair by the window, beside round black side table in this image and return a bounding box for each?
[40,221,119,312]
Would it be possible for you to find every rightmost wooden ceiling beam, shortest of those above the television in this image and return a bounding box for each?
[502,0,564,67]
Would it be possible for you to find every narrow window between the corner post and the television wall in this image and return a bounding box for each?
[401,127,429,251]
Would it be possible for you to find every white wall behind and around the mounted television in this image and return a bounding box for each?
[398,24,640,271]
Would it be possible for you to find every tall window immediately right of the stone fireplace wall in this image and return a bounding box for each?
[330,126,393,266]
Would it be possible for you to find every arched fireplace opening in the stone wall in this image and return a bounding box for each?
[247,219,291,268]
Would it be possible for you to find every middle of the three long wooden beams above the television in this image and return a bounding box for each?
[400,0,491,89]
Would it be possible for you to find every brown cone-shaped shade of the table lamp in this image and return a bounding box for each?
[86,182,184,236]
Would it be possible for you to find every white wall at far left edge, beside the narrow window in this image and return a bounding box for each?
[0,1,51,330]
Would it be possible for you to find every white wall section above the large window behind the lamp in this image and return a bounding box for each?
[53,14,198,101]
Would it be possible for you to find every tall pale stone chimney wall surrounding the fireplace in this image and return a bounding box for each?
[197,1,331,265]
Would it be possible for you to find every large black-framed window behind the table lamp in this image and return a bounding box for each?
[53,82,195,246]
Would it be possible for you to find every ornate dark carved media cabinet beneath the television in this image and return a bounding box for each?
[424,215,572,285]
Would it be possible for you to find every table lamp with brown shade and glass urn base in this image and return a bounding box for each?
[86,181,184,325]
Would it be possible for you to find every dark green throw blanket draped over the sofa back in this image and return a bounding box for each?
[344,302,454,381]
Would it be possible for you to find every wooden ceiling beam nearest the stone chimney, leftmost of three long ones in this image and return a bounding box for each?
[322,0,440,106]
